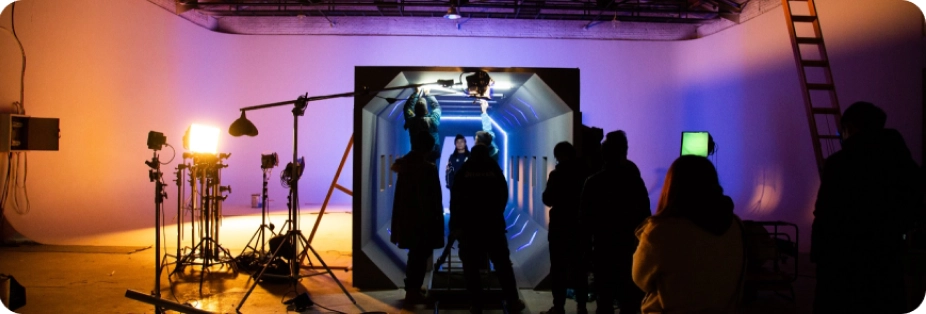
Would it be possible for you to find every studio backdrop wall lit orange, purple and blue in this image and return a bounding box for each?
[0,0,926,250]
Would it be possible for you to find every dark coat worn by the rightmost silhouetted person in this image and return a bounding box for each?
[810,129,922,263]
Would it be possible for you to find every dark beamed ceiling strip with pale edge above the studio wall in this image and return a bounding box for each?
[148,0,781,40]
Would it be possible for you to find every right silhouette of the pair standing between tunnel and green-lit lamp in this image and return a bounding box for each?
[581,131,650,314]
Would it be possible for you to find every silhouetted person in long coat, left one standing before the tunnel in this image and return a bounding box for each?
[389,133,444,305]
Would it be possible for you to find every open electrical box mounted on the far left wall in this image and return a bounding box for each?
[0,114,61,152]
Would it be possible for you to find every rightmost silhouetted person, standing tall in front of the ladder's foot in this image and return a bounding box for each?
[810,102,922,313]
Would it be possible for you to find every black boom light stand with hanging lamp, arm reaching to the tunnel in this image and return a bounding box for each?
[228,80,454,313]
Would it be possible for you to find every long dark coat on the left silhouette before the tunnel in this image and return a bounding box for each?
[389,151,444,249]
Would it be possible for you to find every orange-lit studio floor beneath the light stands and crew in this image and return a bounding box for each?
[0,211,828,314]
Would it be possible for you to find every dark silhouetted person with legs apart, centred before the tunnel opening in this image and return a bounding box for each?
[450,145,524,313]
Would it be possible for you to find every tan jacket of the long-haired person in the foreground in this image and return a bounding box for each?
[633,212,745,314]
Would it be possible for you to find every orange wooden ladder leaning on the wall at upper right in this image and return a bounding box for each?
[781,0,842,173]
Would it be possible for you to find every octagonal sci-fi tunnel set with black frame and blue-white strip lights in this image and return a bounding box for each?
[353,67,581,289]
